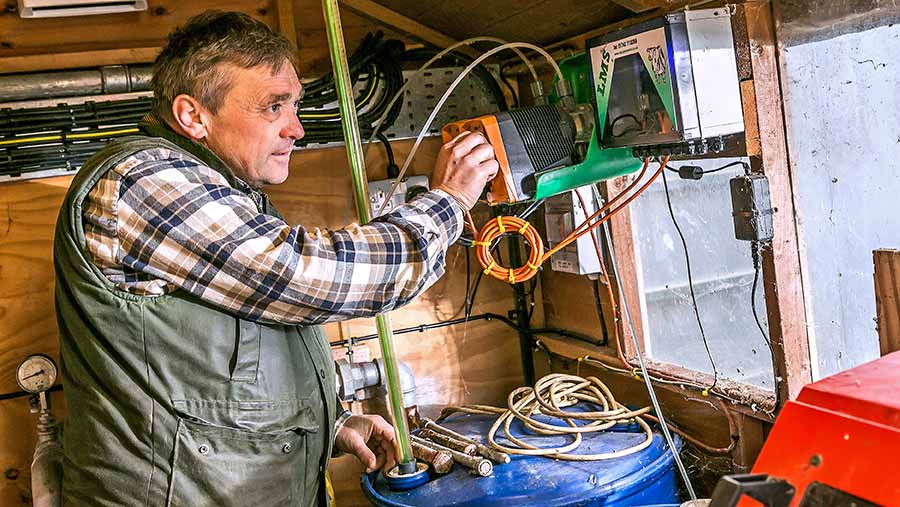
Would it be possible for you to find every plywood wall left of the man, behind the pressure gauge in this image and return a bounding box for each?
[0,178,69,506]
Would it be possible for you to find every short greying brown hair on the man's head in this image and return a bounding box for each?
[150,11,297,119]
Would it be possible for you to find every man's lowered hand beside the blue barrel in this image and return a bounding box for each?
[334,415,396,472]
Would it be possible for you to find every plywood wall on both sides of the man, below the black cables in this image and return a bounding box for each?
[0,136,528,505]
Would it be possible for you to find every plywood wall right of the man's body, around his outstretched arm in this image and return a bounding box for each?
[266,139,528,507]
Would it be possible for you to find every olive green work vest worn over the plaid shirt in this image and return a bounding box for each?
[54,120,340,507]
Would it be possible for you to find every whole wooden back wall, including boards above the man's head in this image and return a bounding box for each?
[0,0,528,506]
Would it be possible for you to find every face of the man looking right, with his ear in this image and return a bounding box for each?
[206,62,304,187]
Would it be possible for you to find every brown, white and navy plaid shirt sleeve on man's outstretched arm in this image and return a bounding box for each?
[83,148,463,325]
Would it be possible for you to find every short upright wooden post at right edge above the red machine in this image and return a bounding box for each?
[873,249,900,356]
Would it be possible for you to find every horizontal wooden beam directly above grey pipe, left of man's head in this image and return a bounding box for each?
[0,47,162,74]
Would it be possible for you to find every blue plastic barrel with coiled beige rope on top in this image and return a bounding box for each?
[362,415,681,507]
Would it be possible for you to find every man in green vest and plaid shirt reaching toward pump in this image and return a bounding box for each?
[54,12,497,506]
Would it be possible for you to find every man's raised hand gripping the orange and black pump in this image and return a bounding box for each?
[431,131,500,211]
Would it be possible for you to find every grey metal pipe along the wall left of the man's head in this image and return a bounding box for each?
[0,65,153,102]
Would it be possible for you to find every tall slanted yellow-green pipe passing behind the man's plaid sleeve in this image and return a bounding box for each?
[322,0,417,474]
